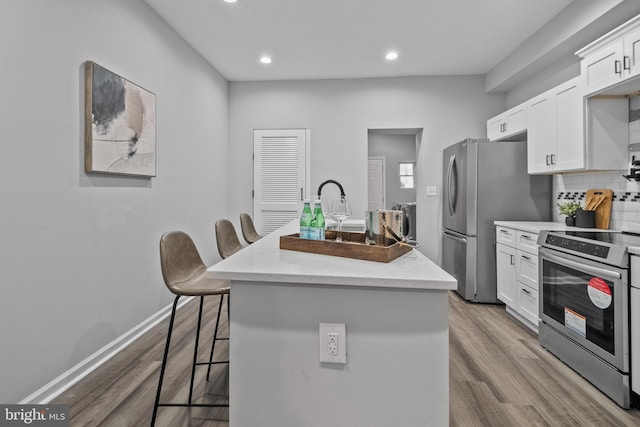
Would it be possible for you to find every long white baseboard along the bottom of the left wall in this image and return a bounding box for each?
[18,297,193,405]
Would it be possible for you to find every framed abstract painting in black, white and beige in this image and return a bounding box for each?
[85,61,156,177]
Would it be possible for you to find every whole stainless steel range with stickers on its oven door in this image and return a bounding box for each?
[538,231,640,408]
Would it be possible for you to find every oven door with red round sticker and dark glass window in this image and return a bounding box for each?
[539,248,629,372]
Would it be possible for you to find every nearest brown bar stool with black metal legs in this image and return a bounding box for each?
[151,231,230,426]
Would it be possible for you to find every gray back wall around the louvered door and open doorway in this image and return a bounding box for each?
[229,76,505,262]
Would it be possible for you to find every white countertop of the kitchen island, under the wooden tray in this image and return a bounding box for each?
[207,220,457,290]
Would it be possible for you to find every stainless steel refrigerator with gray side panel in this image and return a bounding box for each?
[441,139,552,303]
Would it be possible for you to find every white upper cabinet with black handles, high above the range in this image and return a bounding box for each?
[576,15,640,95]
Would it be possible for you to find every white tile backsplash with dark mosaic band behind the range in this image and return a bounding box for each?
[553,171,640,233]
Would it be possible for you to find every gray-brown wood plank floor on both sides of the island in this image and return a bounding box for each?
[53,292,640,427]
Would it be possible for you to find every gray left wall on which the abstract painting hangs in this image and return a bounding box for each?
[0,0,228,403]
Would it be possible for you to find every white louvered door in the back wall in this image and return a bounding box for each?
[253,129,310,234]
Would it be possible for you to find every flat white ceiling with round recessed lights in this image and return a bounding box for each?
[145,0,572,81]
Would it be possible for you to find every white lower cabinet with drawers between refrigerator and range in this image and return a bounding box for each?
[496,226,539,332]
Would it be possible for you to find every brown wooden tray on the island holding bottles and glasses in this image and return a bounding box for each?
[280,230,413,262]
